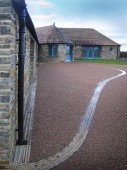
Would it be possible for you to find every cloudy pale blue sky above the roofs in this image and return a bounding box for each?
[26,0,127,51]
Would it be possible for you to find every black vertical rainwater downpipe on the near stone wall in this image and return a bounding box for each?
[16,5,27,145]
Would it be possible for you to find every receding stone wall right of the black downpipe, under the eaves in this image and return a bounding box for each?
[24,27,38,109]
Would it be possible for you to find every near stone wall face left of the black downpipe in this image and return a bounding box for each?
[0,0,18,166]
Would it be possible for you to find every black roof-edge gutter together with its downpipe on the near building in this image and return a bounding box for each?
[12,0,39,145]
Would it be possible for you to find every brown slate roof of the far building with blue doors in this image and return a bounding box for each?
[36,25,119,45]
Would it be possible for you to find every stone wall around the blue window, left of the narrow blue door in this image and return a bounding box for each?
[39,44,66,62]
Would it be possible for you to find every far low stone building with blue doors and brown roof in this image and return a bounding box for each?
[36,24,120,61]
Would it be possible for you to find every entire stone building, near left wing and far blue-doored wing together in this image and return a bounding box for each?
[0,0,120,169]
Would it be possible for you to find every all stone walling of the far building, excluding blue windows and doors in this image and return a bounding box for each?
[39,44,120,62]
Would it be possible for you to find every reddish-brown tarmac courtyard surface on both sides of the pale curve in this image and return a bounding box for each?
[30,62,127,170]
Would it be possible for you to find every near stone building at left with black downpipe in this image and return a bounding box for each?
[0,0,38,169]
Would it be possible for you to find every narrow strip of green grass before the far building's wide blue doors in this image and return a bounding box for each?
[75,59,127,65]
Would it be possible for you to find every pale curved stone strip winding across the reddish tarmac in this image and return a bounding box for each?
[18,69,126,170]
